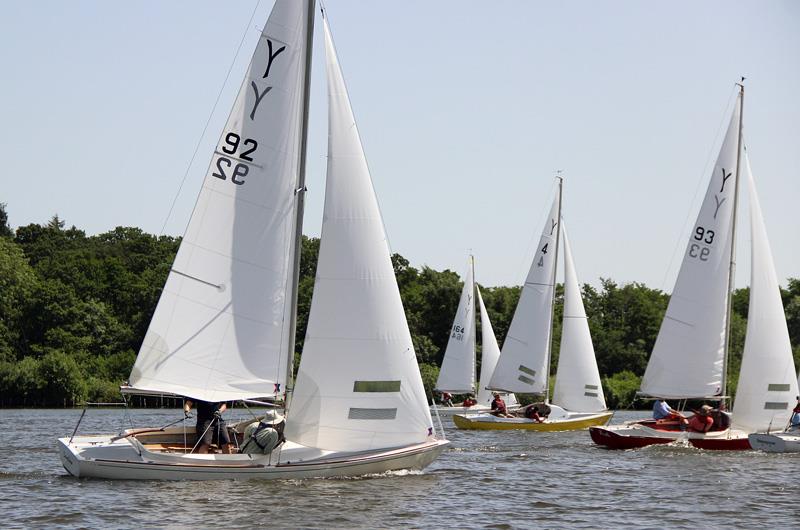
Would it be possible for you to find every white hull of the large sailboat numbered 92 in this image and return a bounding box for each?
[58,428,449,480]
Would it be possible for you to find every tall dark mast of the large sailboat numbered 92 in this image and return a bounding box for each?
[284,0,315,396]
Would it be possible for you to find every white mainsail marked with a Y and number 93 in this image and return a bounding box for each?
[641,96,741,398]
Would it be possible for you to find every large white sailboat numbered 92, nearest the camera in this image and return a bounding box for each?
[58,0,448,479]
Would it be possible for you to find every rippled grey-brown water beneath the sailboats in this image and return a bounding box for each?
[0,410,800,529]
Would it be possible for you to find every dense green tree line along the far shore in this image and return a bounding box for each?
[0,204,800,408]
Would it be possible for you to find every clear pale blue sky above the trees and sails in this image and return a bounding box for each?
[0,0,800,291]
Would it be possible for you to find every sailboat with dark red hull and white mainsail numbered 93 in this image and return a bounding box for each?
[590,85,797,449]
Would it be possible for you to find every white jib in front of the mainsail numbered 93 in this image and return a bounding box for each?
[733,154,798,432]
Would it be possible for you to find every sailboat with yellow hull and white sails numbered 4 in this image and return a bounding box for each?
[453,179,612,431]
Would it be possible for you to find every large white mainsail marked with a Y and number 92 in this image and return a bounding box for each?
[130,0,308,401]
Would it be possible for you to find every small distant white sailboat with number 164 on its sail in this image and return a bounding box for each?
[431,256,518,416]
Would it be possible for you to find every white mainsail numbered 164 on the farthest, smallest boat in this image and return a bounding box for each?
[436,256,475,394]
